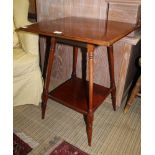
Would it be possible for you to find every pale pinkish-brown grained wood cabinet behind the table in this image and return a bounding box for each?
[36,0,141,107]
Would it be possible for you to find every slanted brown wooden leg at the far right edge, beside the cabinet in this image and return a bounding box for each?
[124,77,141,113]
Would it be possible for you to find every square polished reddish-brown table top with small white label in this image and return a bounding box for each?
[18,17,138,46]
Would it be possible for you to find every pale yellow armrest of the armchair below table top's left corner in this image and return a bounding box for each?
[18,22,39,55]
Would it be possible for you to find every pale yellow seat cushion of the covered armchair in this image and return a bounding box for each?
[13,48,39,77]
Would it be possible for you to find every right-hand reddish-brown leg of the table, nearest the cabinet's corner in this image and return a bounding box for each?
[107,45,116,111]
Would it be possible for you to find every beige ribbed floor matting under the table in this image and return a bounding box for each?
[14,98,141,155]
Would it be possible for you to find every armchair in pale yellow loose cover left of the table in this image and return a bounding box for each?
[13,0,43,106]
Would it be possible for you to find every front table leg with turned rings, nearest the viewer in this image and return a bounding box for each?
[86,44,94,146]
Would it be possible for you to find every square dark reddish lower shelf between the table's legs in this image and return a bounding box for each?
[49,78,111,114]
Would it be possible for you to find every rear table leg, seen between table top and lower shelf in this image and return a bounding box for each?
[72,46,78,78]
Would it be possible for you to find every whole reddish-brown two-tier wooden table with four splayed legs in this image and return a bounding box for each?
[19,17,138,146]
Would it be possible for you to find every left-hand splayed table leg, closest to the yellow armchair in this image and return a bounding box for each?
[42,38,56,119]
